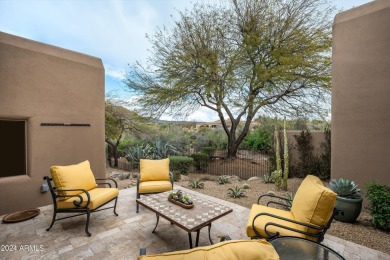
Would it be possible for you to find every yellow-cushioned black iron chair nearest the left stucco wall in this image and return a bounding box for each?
[43,161,119,236]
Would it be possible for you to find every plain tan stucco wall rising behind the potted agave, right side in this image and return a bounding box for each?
[332,0,390,197]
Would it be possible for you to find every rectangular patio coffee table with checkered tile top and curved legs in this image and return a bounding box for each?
[137,190,233,248]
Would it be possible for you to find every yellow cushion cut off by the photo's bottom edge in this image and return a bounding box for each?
[138,240,279,260]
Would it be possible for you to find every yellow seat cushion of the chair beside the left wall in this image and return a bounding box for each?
[57,188,119,210]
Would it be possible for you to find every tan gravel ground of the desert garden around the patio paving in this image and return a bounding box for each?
[106,168,390,254]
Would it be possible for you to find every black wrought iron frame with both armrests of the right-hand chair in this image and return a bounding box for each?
[252,194,340,243]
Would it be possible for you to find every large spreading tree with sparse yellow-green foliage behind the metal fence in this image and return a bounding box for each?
[124,0,333,157]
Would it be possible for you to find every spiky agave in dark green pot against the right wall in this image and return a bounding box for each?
[328,178,363,223]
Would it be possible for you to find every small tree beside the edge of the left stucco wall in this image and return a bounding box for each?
[105,100,144,167]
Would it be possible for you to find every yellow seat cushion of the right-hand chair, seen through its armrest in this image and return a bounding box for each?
[246,204,305,238]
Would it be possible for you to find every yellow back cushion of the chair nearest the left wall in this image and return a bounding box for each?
[50,161,97,200]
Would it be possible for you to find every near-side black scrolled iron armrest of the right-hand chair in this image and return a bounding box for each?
[252,213,329,239]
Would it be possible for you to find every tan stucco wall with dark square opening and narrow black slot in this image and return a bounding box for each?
[0,32,105,215]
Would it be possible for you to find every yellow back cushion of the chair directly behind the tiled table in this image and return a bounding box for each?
[140,158,170,182]
